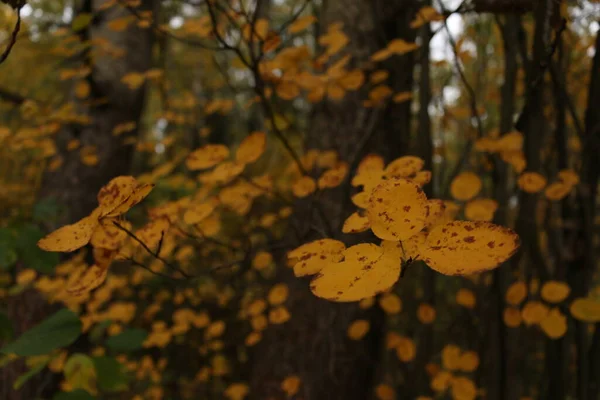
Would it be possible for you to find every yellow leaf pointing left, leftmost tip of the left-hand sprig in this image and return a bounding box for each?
[37,208,100,253]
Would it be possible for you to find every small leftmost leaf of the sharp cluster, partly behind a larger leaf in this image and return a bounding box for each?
[288,239,346,276]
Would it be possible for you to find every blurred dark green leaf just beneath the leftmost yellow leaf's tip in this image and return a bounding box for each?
[16,224,59,274]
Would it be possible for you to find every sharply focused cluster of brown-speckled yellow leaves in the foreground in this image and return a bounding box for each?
[288,155,519,300]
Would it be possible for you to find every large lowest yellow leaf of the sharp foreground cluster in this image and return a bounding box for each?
[310,243,400,302]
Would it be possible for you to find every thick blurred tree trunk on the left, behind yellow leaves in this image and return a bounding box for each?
[0,0,154,400]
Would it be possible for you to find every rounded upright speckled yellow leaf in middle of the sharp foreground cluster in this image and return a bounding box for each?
[367,178,427,241]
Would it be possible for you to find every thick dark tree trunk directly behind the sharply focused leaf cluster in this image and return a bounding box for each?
[250,0,417,400]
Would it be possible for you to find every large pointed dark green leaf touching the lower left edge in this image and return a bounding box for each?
[0,308,81,356]
